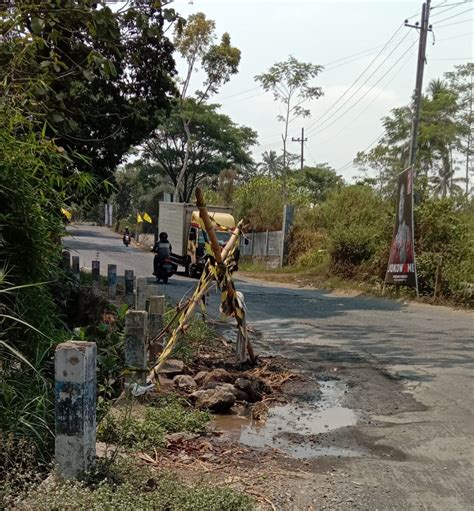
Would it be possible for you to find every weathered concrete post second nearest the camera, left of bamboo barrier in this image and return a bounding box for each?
[125,311,148,385]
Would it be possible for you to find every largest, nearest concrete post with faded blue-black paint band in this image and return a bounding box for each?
[55,341,97,479]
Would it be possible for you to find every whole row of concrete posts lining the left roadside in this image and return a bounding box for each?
[55,251,165,479]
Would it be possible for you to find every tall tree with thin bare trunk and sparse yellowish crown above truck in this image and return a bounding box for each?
[174,12,240,201]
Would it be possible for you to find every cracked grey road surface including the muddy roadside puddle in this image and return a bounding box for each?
[66,226,474,511]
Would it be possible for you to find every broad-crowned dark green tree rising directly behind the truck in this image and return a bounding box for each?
[143,99,257,202]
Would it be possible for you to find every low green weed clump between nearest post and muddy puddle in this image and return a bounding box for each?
[97,396,211,451]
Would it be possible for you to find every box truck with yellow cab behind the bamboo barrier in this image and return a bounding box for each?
[158,202,238,278]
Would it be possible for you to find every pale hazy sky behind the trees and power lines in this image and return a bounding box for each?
[168,0,474,180]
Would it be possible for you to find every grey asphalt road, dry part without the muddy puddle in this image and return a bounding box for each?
[65,226,474,510]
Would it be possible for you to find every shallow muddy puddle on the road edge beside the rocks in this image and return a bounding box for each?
[214,380,359,458]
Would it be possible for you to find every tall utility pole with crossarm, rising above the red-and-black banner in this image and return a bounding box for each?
[405,0,432,172]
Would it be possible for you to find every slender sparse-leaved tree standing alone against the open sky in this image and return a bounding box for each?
[255,55,323,193]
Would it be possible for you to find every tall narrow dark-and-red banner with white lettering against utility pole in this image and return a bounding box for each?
[385,167,418,291]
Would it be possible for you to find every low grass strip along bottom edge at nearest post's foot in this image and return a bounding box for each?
[20,459,255,511]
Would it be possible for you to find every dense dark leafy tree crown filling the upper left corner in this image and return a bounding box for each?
[0,0,180,183]
